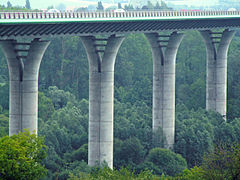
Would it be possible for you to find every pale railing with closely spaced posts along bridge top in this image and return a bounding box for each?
[0,11,240,19]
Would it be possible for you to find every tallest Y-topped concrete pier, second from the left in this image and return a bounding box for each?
[80,36,124,168]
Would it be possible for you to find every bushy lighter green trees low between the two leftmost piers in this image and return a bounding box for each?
[39,96,88,179]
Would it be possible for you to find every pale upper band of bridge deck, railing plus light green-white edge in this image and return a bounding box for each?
[0,11,240,24]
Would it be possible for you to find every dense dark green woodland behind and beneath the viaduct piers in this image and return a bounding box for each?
[0,17,240,179]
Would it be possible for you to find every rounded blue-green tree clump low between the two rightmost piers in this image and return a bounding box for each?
[174,105,215,167]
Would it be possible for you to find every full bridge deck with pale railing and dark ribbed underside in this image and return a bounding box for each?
[0,11,240,39]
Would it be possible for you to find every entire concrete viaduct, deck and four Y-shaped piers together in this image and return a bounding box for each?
[0,11,240,168]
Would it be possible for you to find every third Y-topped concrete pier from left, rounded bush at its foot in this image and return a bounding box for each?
[145,32,183,149]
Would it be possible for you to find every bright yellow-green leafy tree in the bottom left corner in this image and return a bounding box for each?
[0,131,47,180]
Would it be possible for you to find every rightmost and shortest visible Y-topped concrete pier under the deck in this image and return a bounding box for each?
[200,30,235,118]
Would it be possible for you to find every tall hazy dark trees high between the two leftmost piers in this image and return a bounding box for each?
[39,37,88,99]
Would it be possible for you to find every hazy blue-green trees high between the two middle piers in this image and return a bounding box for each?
[115,34,153,106]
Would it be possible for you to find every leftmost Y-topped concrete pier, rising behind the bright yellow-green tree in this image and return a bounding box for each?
[0,40,49,136]
